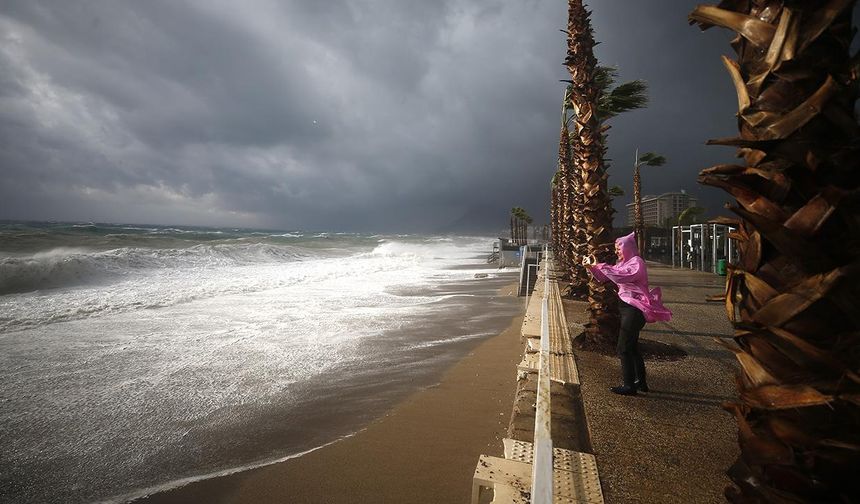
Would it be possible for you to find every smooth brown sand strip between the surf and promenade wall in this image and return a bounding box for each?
[133,285,523,504]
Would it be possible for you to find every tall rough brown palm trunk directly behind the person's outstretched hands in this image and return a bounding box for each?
[564,0,619,349]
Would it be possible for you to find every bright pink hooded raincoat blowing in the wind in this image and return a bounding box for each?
[590,233,672,322]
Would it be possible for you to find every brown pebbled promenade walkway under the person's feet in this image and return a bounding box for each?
[566,264,738,504]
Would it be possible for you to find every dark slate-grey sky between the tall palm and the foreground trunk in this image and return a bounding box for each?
[593,0,737,220]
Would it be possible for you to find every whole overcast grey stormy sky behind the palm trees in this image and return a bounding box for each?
[0,0,852,231]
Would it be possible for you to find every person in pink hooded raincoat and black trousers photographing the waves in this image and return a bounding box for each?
[582,233,672,395]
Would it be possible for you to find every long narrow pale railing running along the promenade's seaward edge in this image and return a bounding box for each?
[531,248,552,504]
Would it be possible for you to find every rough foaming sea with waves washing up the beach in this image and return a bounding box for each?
[0,221,522,503]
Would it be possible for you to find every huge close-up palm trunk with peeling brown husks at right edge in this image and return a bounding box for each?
[690,0,860,503]
